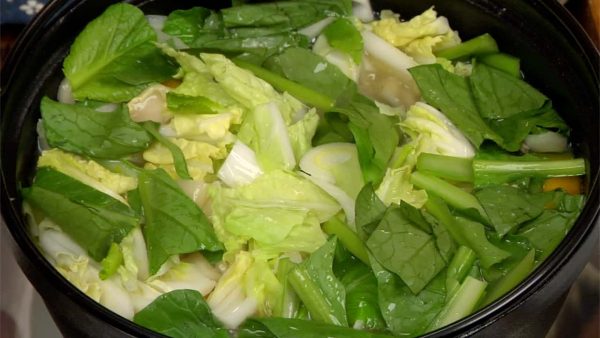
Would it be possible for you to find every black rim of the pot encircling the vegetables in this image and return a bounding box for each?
[0,0,600,337]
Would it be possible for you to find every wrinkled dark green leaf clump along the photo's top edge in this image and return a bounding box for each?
[164,1,351,65]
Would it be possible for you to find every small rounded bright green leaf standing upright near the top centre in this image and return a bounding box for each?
[323,18,363,64]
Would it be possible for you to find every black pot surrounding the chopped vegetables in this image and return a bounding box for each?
[0,0,600,337]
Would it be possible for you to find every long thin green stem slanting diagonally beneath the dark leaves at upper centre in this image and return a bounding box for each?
[233,59,335,111]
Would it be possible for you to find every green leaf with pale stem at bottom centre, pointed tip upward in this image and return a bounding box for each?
[289,237,348,326]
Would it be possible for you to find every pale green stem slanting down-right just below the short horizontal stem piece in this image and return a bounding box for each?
[410,171,489,224]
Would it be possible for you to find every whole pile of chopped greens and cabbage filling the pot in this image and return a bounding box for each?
[23,0,585,337]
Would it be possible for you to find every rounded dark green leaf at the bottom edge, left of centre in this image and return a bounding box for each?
[133,289,229,338]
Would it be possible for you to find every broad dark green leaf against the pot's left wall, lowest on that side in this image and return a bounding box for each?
[23,167,139,262]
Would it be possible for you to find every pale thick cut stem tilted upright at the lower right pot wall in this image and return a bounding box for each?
[428,276,487,331]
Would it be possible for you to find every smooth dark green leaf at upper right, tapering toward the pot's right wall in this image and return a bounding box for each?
[469,63,548,120]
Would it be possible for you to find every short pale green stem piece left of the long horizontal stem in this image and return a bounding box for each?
[417,153,473,182]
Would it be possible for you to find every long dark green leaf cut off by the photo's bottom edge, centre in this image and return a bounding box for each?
[237,317,392,338]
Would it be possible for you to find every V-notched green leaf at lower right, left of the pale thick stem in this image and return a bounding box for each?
[371,261,446,337]
